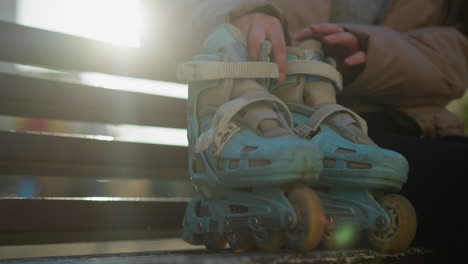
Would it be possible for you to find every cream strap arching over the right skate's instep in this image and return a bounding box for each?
[308,104,367,135]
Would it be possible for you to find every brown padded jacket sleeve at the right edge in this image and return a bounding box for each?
[343,25,468,108]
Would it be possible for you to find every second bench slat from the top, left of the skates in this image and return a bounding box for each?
[0,73,186,128]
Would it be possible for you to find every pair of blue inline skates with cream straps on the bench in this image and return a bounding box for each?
[178,24,416,252]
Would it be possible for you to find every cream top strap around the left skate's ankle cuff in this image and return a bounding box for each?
[177,61,278,82]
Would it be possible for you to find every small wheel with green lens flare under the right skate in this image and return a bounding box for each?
[322,223,360,250]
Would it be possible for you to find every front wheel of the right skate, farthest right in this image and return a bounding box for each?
[368,194,417,253]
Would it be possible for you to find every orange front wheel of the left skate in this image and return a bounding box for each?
[285,185,325,252]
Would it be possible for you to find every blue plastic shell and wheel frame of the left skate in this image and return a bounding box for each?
[182,25,322,245]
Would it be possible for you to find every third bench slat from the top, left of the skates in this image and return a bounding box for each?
[0,131,189,180]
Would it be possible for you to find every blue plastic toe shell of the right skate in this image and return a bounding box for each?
[292,105,409,191]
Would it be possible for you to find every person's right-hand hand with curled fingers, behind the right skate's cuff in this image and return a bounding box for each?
[292,23,367,83]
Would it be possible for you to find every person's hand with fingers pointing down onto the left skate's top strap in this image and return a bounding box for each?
[233,13,287,83]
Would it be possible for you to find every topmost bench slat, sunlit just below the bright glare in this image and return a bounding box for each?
[0,21,175,81]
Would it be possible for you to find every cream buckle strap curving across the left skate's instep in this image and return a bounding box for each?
[194,91,292,156]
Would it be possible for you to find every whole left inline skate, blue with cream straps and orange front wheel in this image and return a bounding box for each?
[178,24,326,254]
